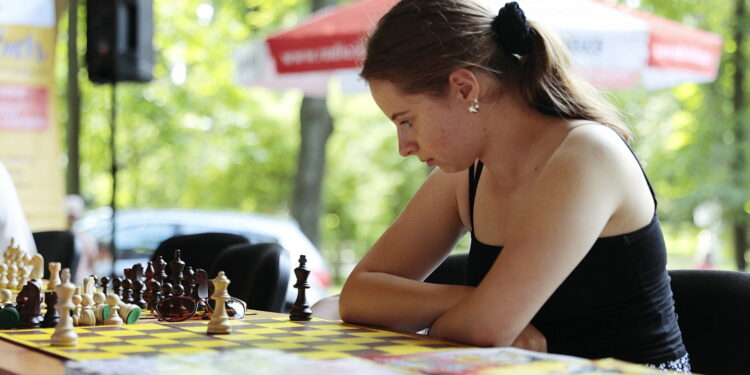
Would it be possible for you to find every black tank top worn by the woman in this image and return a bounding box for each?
[466,161,686,364]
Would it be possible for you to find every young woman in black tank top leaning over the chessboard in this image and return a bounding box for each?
[339,0,689,371]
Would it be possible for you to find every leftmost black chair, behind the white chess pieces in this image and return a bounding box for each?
[32,230,81,280]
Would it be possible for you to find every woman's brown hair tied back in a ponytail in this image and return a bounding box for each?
[360,0,631,141]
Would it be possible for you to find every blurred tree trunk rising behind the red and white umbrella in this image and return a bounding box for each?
[292,0,336,246]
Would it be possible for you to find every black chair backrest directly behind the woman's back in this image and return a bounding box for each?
[669,270,750,374]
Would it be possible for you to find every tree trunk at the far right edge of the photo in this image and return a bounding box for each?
[732,0,748,271]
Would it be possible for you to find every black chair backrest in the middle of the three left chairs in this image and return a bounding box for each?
[151,232,249,273]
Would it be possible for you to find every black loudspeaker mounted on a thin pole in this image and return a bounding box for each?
[86,0,154,83]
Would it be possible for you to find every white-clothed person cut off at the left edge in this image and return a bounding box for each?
[0,162,37,255]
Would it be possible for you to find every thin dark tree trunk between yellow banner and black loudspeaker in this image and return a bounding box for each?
[65,0,81,195]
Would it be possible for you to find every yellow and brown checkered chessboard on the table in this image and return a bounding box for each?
[0,316,462,360]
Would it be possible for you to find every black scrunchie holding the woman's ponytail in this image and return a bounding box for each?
[491,1,531,56]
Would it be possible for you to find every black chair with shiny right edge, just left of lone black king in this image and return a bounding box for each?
[214,243,292,312]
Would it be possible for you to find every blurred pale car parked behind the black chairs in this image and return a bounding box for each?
[75,207,331,306]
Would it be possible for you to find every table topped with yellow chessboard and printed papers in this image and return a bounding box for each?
[0,311,658,375]
